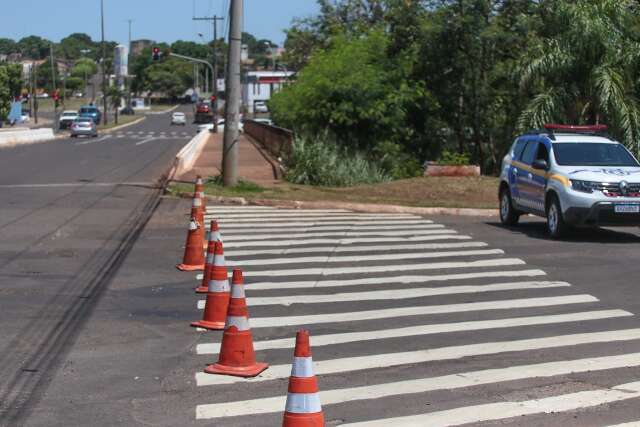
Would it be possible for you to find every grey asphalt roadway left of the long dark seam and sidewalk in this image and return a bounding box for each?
[0,107,196,426]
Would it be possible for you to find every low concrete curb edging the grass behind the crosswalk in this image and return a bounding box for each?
[195,196,498,216]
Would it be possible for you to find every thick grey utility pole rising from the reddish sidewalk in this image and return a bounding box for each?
[222,0,243,187]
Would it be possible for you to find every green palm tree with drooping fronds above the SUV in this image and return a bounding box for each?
[518,0,640,153]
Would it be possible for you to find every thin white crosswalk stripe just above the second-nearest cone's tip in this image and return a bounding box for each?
[227,249,504,266]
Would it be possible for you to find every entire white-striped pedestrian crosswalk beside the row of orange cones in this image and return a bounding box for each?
[194,206,640,427]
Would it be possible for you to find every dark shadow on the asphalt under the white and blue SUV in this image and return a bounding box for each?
[485,221,640,243]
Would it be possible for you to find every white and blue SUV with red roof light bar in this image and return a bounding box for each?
[499,125,640,238]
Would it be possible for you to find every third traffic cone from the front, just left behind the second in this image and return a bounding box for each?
[191,242,231,330]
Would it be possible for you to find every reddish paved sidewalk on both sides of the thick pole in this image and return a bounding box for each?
[177,133,278,187]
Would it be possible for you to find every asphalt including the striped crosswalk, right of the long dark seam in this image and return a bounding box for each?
[16,199,640,427]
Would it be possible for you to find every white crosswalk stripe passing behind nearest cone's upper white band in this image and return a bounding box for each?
[196,329,640,388]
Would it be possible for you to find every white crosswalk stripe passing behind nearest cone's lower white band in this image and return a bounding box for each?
[196,352,640,427]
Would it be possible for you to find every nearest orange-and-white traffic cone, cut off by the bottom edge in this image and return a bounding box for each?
[282,330,324,427]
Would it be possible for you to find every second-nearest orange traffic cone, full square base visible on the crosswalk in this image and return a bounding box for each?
[204,268,269,377]
